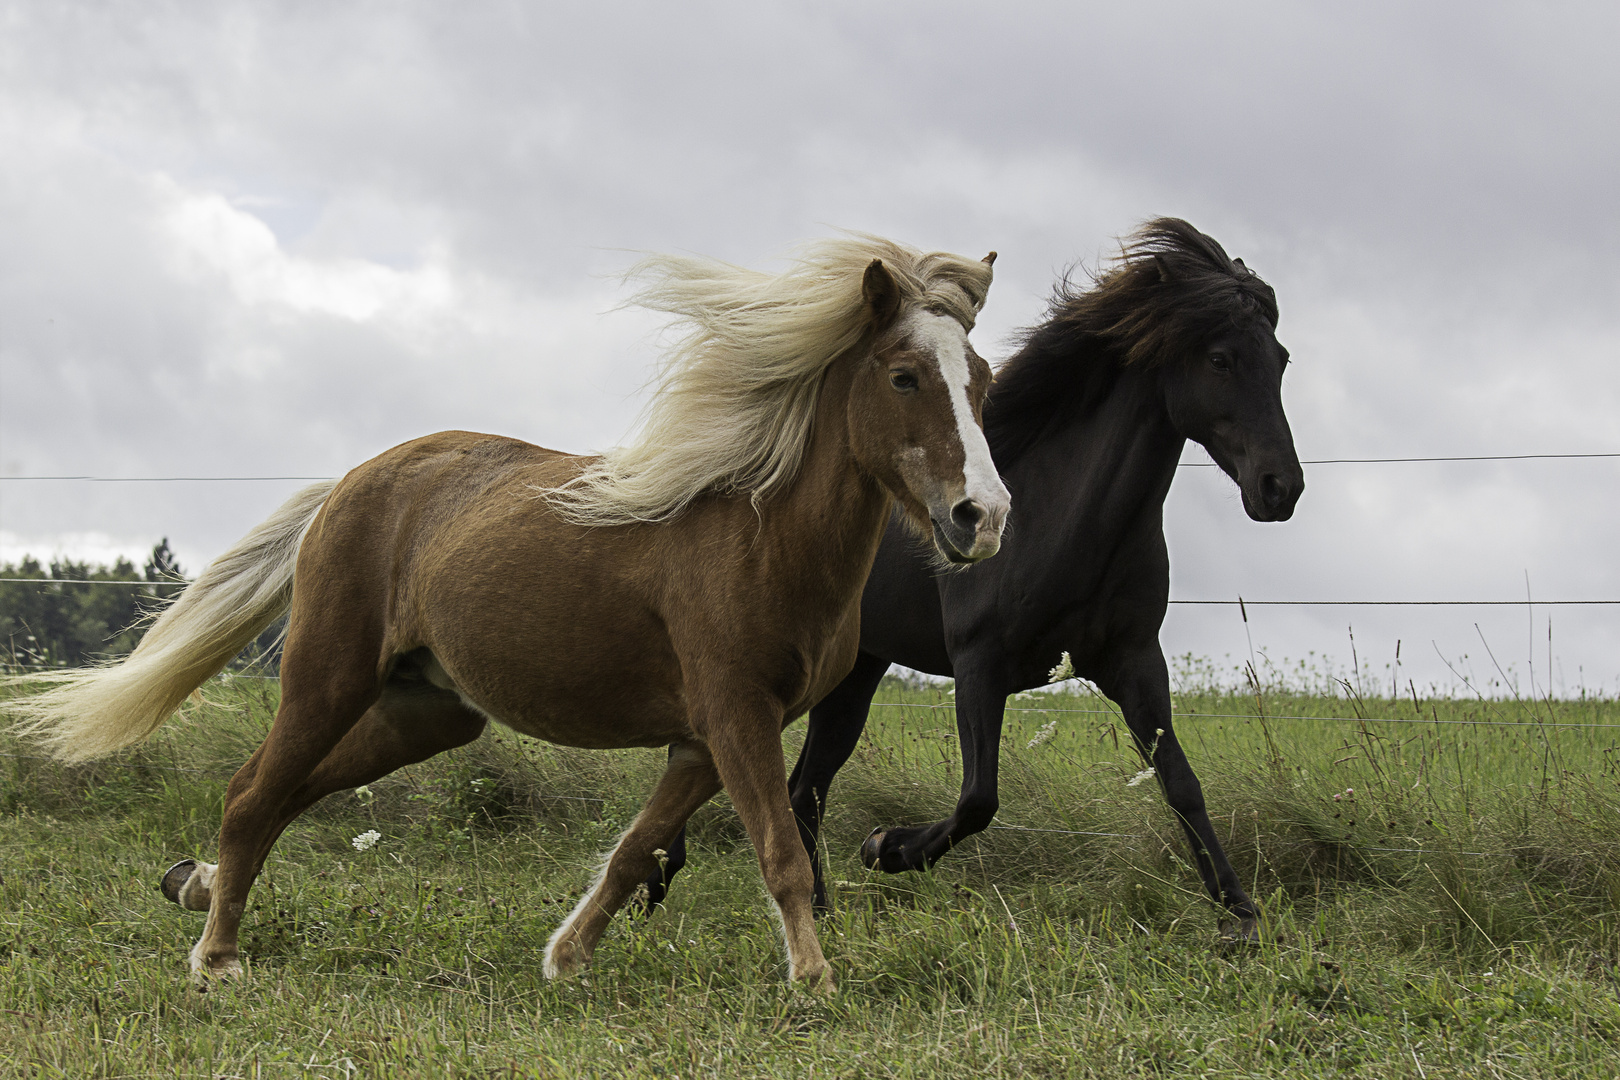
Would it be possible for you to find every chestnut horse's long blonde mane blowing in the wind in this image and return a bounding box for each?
[541,233,990,525]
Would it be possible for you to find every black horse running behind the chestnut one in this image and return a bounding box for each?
[648,217,1304,938]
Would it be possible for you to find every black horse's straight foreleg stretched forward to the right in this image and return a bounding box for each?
[1097,648,1260,941]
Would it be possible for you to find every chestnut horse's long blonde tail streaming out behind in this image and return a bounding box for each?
[5,481,337,761]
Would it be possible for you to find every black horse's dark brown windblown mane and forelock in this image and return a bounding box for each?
[985,217,1277,468]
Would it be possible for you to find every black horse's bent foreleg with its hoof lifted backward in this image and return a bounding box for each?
[860,669,1008,874]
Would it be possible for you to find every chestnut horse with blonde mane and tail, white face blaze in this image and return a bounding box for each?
[12,235,1009,989]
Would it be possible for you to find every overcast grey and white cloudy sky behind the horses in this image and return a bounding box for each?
[0,2,1620,691]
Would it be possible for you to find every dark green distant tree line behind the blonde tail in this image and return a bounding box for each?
[0,536,280,669]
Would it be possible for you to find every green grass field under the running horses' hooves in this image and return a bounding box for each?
[0,678,1620,1080]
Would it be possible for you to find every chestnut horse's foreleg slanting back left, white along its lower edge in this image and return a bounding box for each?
[544,742,719,978]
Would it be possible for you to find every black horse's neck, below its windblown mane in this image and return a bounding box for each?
[991,355,1186,554]
